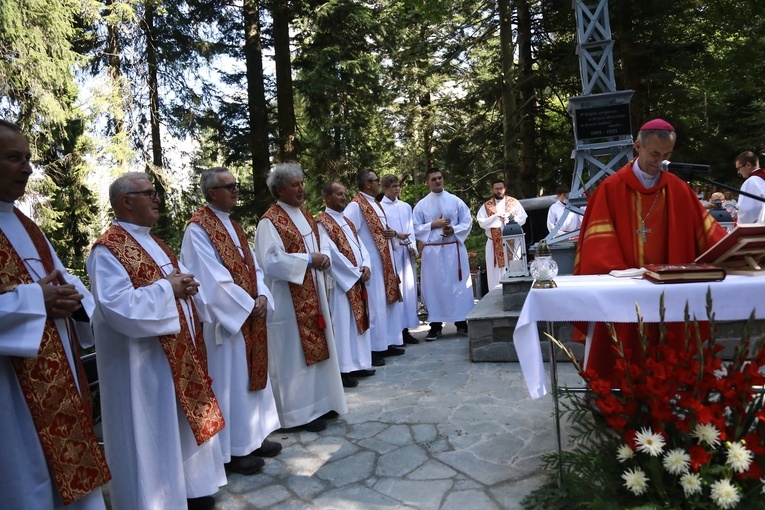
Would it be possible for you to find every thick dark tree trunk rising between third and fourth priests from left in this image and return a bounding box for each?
[243,0,271,215]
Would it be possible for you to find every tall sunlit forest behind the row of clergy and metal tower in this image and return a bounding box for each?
[0,0,765,272]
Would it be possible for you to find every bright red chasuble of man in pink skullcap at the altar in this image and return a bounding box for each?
[574,160,725,377]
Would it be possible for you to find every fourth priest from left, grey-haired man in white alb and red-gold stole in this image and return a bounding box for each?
[255,163,348,432]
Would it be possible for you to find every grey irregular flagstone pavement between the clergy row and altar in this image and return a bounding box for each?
[216,324,576,510]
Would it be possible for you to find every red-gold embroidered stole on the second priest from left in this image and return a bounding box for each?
[96,225,225,445]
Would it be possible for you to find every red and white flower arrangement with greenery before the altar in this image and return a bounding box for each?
[524,293,765,510]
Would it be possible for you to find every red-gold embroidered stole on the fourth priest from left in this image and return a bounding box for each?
[262,204,329,366]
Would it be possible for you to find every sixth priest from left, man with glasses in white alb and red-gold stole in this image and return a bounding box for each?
[344,168,406,366]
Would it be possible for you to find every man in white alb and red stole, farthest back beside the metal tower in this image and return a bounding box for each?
[476,179,528,289]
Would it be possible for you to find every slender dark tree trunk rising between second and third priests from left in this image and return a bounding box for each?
[144,2,170,239]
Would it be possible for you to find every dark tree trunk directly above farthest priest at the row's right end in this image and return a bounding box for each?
[499,0,519,195]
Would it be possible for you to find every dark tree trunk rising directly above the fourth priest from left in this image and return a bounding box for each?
[271,0,296,162]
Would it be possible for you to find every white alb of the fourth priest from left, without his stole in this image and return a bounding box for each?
[255,201,348,427]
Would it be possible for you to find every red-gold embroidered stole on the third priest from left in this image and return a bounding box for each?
[190,207,268,391]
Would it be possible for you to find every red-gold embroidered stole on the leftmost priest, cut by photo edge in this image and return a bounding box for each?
[0,208,111,504]
